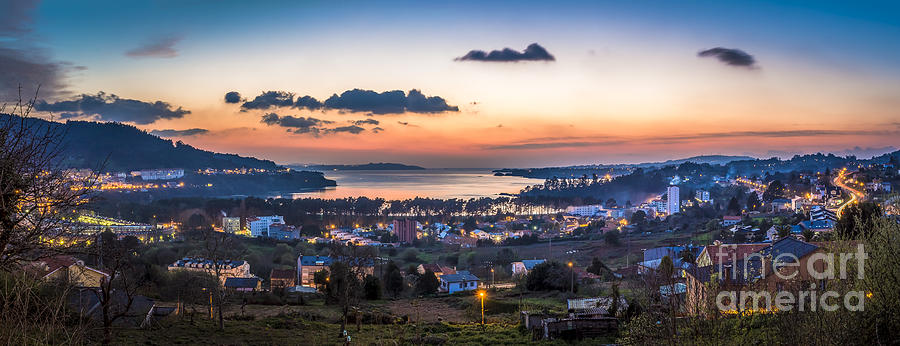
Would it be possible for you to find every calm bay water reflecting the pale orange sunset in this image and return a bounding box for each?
[290,169,543,200]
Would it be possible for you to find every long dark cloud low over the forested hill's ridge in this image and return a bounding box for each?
[34,91,191,124]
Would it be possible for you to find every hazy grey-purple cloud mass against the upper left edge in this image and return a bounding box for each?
[0,0,70,102]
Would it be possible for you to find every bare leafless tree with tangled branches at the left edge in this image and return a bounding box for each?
[0,86,97,269]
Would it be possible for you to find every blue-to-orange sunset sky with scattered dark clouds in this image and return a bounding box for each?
[0,0,900,167]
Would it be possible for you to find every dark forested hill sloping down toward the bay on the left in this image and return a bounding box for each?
[0,114,277,171]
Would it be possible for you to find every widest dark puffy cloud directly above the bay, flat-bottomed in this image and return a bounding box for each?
[325,89,459,114]
